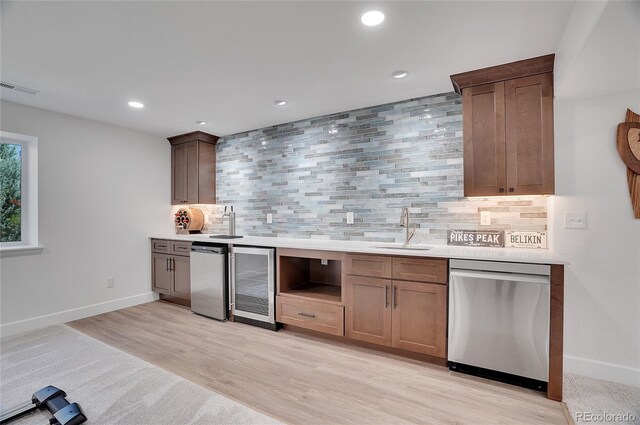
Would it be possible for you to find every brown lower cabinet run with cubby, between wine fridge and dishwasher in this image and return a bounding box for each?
[276,248,448,358]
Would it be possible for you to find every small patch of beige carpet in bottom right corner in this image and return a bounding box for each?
[564,373,640,425]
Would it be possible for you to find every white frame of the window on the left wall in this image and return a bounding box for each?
[0,131,41,251]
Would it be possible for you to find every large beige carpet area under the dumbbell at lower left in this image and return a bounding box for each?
[0,325,279,425]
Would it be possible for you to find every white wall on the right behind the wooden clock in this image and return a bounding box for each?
[550,2,640,386]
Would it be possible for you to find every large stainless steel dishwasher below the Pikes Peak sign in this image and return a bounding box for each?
[448,260,550,391]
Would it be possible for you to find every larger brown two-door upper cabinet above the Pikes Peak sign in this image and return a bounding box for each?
[451,55,555,196]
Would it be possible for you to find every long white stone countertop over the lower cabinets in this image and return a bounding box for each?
[151,233,569,264]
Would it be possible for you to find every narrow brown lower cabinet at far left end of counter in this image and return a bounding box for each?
[151,239,191,301]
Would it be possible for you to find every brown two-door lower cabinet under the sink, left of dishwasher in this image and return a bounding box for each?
[343,255,448,358]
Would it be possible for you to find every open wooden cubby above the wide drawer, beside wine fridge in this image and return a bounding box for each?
[278,249,342,304]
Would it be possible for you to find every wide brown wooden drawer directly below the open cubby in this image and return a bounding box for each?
[276,296,344,336]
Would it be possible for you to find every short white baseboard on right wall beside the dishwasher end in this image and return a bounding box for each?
[564,355,640,387]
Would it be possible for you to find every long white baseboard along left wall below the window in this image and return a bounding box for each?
[0,292,158,338]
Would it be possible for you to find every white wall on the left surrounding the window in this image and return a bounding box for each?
[0,102,171,336]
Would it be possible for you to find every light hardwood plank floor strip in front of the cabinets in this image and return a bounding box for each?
[69,302,567,425]
